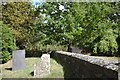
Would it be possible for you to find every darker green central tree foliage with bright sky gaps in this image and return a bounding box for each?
[35,3,82,45]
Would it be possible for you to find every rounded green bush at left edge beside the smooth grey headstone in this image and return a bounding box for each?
[0,21,16,62]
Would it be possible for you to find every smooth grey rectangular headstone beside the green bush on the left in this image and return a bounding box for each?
[12,50,25,71]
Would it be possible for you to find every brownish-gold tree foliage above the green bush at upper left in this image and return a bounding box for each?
[2,2,35,48]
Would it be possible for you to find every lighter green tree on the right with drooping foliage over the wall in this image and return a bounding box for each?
[74,3,118,54]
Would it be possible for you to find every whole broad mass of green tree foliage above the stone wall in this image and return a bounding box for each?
[35,2,120,54]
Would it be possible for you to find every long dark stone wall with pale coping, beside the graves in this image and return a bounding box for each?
[51,51,118,80]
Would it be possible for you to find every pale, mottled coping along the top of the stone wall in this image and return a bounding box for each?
[56,51,118,72]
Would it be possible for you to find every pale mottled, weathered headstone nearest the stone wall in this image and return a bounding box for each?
[34,54,50,78]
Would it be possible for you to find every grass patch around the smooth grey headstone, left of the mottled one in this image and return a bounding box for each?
[2,58,39,78]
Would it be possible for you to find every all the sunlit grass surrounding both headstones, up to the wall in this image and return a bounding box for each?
[2,57,64,78]
